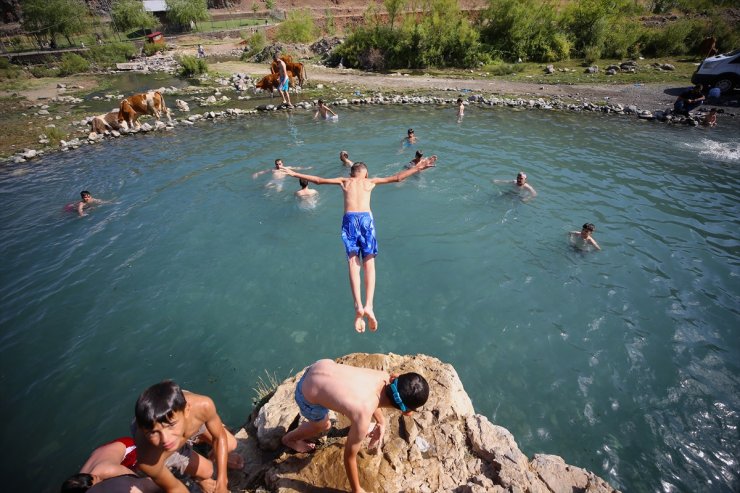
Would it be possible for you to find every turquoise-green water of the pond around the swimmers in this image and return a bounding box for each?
[0,103,740,492]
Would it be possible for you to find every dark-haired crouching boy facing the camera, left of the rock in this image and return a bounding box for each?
[134,380,244,493]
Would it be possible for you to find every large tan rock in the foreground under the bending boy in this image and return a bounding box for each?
[229,354,615,493]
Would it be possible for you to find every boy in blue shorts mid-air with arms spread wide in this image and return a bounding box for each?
[281,156,437,333]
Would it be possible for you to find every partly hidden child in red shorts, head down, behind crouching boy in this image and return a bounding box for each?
[61,437,142,493]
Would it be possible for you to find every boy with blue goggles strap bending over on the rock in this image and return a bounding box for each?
[283,359,429,493]
